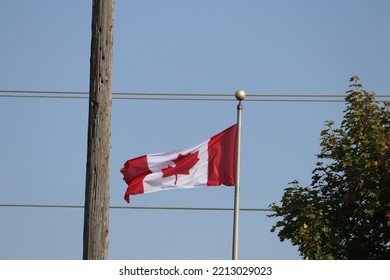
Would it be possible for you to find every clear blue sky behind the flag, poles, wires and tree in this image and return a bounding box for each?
[0,0,390,259]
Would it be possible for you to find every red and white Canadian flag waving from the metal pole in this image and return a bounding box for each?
[121,124,237,203]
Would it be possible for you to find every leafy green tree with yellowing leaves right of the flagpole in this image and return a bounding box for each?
[269,76,390,259]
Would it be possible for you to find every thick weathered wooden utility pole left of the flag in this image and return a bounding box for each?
[83,0,114,260]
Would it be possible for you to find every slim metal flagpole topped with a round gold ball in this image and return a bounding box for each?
[232,89,246,260]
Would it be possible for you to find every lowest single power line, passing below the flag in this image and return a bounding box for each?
[0,204,272,212]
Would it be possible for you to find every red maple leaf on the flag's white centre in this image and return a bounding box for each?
[161,151,199,185]
